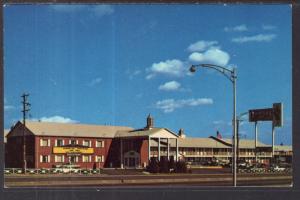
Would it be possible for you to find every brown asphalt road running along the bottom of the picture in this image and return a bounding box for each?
[5,174,292,188]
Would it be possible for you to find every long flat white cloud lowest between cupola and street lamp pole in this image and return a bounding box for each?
[155,98,213,113]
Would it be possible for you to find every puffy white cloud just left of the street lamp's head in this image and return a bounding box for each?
[146,59,186,80]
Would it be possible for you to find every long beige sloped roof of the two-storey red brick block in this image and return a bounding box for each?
[12,121,133,138]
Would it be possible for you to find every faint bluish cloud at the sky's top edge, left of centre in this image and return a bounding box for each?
[50,4,114,18]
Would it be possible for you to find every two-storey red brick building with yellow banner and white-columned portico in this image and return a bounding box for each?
[6,116,178,168]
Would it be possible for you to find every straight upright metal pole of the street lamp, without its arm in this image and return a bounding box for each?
[232,69,237,187]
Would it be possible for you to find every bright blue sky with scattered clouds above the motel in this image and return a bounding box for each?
[4,4,292,144]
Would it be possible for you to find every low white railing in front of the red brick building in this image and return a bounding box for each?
[4,168,101,174]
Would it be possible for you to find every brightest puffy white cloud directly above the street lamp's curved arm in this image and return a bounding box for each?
[189,48,230,66]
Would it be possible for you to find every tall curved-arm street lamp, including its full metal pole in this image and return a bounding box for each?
[190,64,237,187]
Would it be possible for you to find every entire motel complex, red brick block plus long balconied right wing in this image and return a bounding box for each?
[5,115,292,169]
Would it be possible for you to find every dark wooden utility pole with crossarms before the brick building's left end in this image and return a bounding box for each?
[21,93,30,174]
